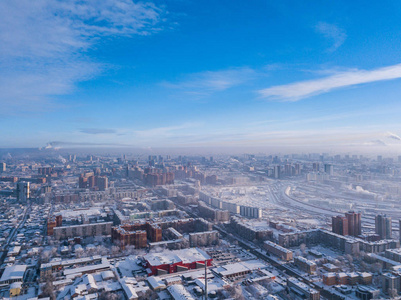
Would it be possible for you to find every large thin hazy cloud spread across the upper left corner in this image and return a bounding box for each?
[0,0,164,113]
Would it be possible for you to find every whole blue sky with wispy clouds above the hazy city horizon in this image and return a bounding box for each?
[0,0,401,151]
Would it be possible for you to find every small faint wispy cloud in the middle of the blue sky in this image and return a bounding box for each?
[162,67,257,97]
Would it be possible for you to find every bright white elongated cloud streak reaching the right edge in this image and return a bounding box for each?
[258,64,401,101]
